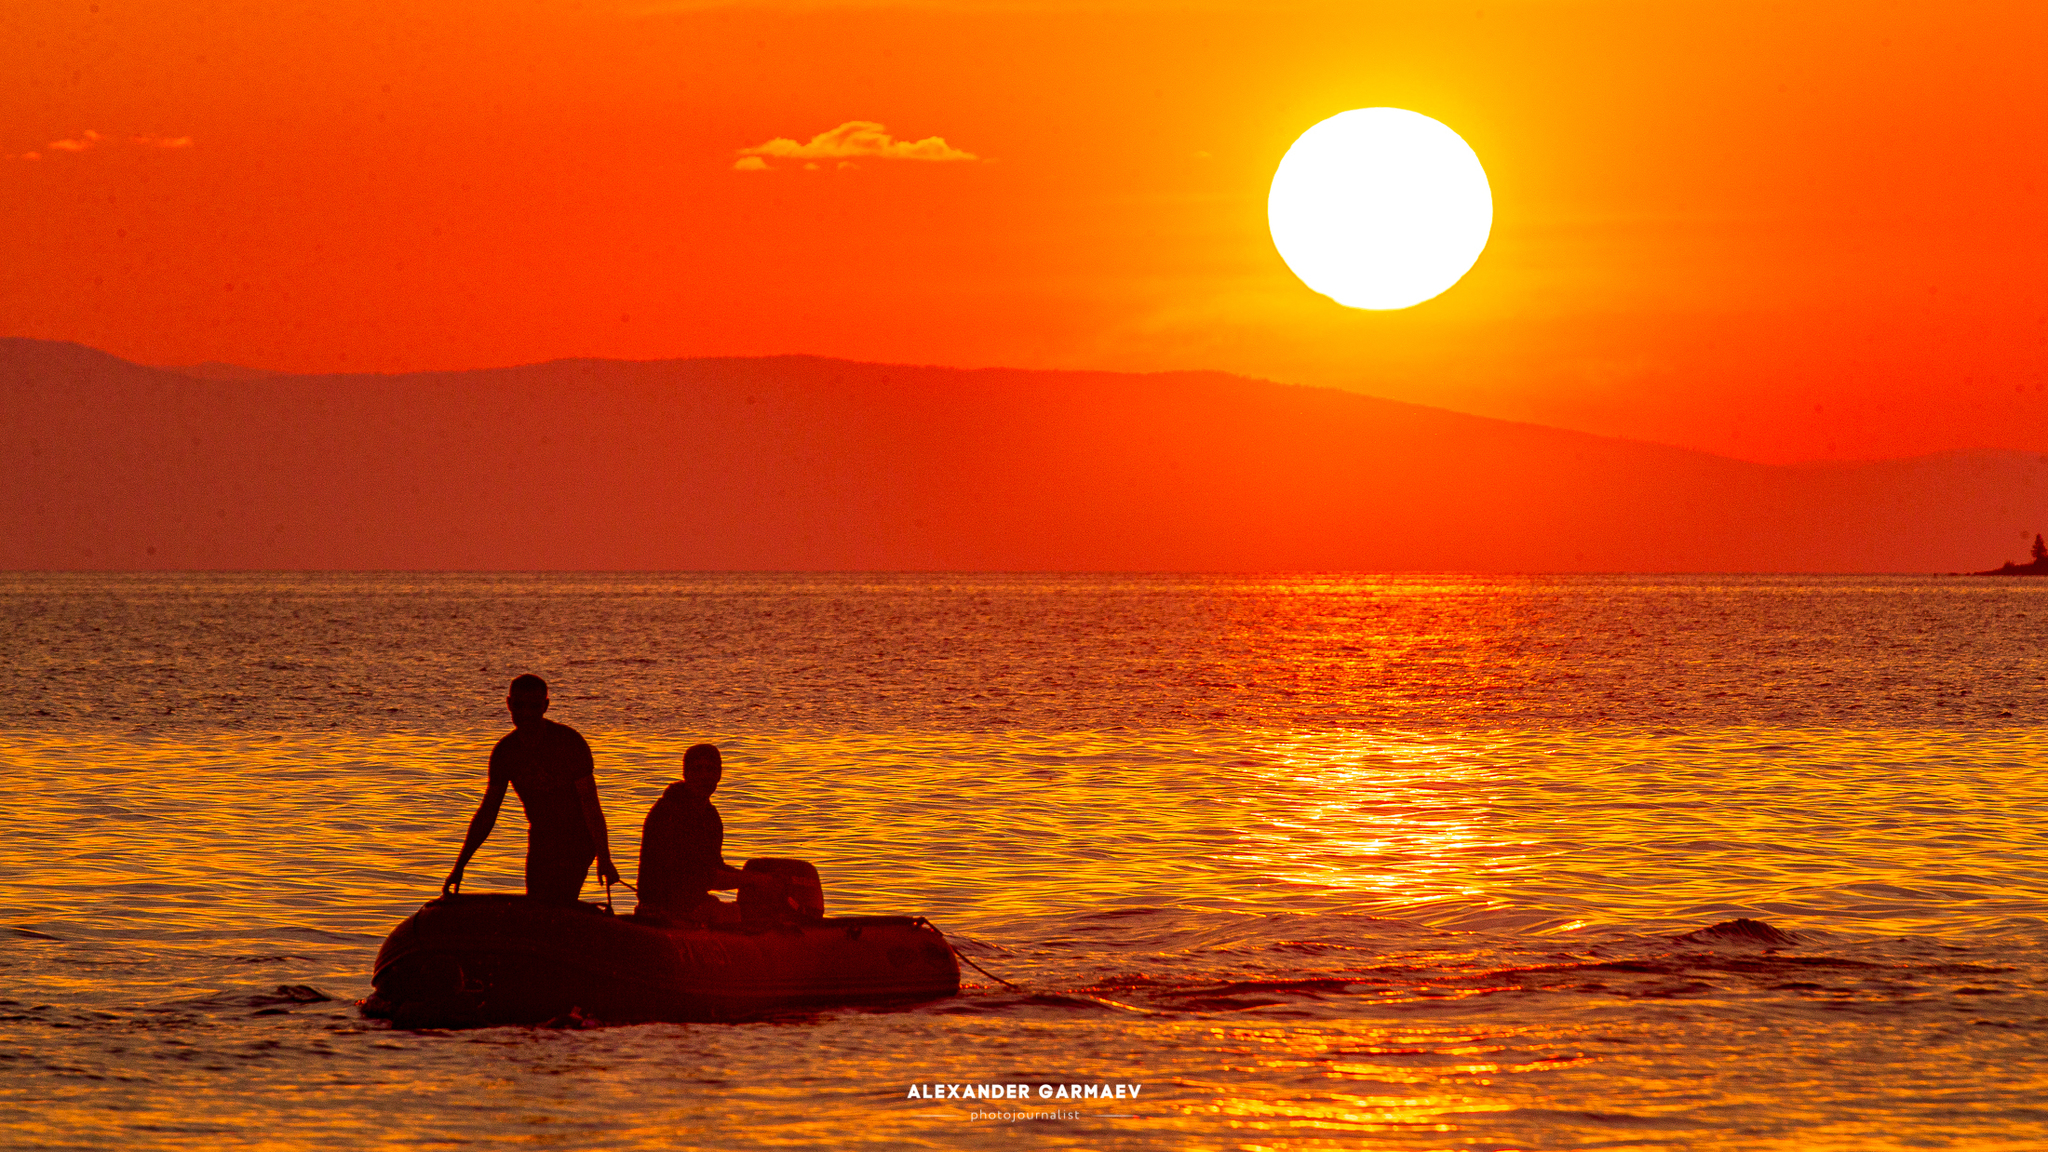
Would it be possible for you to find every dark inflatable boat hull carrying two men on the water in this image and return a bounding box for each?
[362,894,961,1027]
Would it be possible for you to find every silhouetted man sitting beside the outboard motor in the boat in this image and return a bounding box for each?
[637,744,748,924]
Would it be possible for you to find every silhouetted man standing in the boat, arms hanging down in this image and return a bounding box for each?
[440,672,618,904]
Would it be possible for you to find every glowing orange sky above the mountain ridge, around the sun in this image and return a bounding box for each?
[0,0,2048,461]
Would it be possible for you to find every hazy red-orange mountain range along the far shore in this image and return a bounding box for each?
[0,338,2048,572]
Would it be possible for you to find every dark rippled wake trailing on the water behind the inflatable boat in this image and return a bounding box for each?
[924,908,2023,1017]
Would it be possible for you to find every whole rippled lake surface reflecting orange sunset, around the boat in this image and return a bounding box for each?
[0,574,2048,1150]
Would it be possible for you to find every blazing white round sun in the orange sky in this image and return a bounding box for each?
[1266,109,1493,310]
